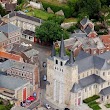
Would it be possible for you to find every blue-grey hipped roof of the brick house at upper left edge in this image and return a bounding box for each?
[0,23,20,34]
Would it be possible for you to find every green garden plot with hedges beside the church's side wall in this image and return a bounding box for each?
[83,95,101,110]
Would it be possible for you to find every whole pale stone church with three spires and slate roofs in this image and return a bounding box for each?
[46,39,110,107]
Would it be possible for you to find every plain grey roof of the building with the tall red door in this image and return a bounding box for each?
[0,75,28,90]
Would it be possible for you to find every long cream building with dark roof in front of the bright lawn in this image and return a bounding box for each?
[2,11,42,32]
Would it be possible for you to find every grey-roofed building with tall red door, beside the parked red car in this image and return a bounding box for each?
[0,74,30,102]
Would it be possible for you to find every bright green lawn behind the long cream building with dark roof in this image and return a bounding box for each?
[25,7,54,20]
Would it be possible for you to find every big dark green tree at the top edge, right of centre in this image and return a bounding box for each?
[76,0,101,17]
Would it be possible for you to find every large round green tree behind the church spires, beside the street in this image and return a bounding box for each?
[35,21,69,44]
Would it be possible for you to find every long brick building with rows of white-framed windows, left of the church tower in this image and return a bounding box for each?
[0,60,40,92]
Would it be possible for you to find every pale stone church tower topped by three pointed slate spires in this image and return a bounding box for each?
[46,38,78,104]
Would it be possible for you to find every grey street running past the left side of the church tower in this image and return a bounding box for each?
[21,39,58,110]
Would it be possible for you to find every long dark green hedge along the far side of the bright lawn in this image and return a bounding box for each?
[42,2,72,18]
